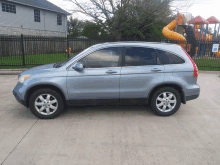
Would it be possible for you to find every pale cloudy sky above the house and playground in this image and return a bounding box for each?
[48,0,220,30]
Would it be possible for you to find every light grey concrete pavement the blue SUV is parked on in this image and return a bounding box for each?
[0,72,220,165]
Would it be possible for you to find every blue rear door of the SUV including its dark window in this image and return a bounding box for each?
[120,47,164,99]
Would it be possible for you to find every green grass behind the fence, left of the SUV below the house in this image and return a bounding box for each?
[0,53,75,69]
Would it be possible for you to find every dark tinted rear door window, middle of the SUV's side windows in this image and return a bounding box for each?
[125,47,158,66]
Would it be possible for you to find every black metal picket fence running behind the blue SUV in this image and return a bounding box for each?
[0,35,220,68]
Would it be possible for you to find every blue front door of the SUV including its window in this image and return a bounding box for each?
[67,47,123,100]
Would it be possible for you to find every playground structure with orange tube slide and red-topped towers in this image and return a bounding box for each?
[162,13,220,57]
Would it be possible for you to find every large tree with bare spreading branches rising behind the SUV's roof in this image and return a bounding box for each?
[69,0,194,40]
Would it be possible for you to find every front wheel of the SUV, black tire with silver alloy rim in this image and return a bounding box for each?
[29,88,64,119]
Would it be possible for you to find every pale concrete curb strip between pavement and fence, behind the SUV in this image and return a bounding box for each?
[0,68,220,75]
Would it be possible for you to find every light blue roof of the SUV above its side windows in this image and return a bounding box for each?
[91,41,181,53]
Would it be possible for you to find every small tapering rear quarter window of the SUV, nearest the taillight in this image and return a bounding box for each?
[157,50,185,64]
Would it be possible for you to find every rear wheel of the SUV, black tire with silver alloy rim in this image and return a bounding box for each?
[151,87,181,116]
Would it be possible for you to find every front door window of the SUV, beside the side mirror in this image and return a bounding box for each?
[79,47,123,68]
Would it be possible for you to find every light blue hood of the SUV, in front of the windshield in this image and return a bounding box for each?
[20,63,55,75]
